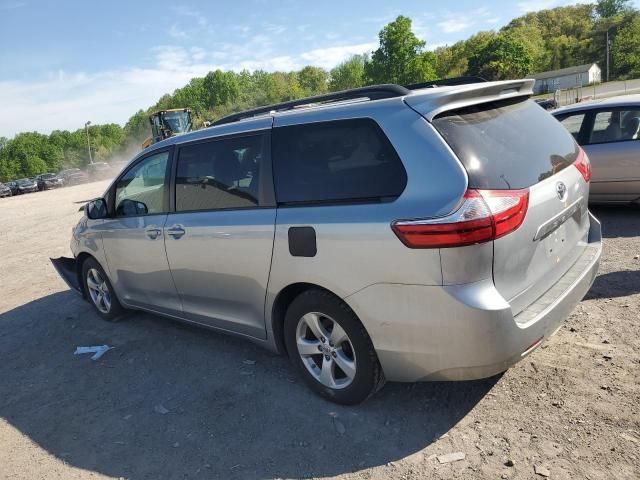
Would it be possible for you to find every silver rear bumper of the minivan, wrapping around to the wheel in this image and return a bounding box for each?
[345,214,602,382]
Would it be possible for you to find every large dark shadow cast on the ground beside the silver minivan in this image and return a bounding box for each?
[0,291,497,479]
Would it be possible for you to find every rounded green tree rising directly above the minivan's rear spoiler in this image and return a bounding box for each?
[469,35,532,80]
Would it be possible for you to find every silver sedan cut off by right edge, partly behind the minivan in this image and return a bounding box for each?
[552,95,640,203]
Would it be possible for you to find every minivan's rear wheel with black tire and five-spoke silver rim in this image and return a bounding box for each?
[284,289,385,405]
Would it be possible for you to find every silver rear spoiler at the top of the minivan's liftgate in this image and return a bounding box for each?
[404,79,535,122]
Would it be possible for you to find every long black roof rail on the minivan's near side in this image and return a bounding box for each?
[211,84,411,126]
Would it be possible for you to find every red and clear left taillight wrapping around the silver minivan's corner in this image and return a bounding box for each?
[391,189,529,248]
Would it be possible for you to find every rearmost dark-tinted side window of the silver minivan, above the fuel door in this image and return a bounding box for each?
[272,119,407,203]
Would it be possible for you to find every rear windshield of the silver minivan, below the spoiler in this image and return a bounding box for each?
[433,99,578,190]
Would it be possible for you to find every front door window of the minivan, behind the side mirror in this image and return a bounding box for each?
[115,152,169,217]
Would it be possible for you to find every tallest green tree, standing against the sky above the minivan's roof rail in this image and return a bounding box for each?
[364,16,436,84]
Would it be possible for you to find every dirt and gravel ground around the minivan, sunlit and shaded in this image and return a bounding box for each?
[0,183,640,480]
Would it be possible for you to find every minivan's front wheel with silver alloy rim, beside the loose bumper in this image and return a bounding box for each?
[82,258,124,322]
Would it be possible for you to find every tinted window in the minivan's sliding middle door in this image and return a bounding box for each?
[176,134,264,212]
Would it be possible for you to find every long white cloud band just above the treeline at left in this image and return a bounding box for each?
[0,41,376,137]
